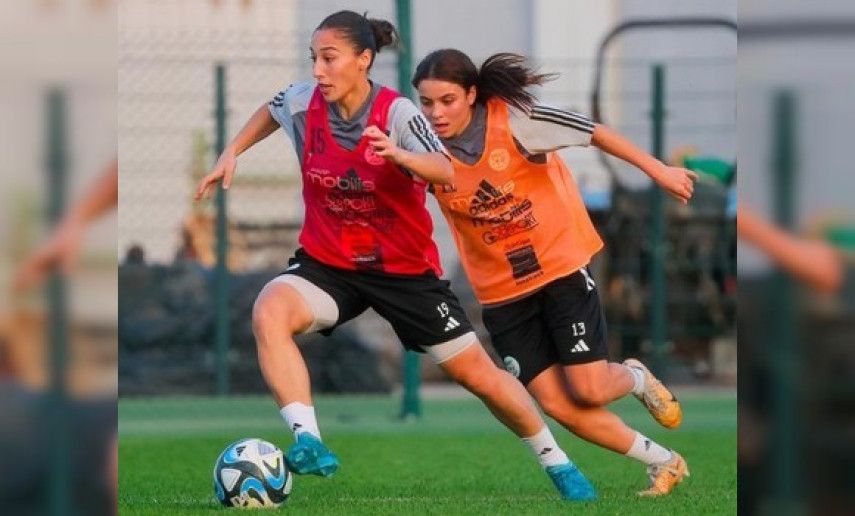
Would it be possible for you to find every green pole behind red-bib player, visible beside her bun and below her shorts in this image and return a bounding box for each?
[395,0,422,419]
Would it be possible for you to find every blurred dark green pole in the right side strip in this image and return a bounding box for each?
[770,91,802,514]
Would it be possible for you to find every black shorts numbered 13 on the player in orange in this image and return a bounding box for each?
[484,271,608,385]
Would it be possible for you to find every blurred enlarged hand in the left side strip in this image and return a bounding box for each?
[13,217,86,291]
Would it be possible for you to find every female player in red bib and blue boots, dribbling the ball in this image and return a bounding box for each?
[197,11,595,500]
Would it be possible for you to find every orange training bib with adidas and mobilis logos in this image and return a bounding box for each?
[434,99,603,304]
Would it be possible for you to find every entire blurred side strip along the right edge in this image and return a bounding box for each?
[738,0,855,514]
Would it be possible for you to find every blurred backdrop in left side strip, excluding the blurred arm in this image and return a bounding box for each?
[0,0,118,514]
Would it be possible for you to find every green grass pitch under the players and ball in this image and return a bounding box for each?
[119,394,736,516]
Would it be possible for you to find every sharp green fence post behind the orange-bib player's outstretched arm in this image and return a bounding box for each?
[650,64,668,377]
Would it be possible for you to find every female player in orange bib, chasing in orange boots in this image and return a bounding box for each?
[412,49,697,496]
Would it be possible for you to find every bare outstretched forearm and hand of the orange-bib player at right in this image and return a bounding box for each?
[591,124,698,203]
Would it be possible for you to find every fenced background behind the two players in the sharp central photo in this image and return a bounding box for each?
[118,0,736,400]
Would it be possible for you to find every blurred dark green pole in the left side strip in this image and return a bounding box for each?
[46,88,73,515]
